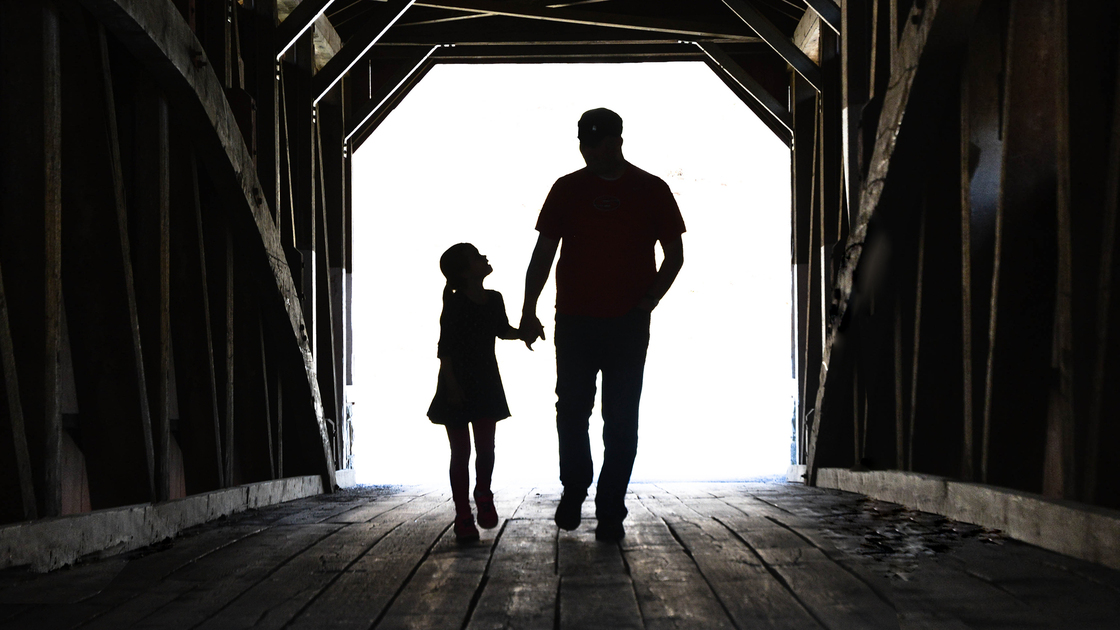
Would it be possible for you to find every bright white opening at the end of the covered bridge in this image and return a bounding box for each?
[348,63,795,487]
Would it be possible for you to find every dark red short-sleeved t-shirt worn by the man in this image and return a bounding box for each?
[536,165,684,317]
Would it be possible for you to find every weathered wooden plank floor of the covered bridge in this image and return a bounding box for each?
[0,483,1120,630]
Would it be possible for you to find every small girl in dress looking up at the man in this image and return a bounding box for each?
[428,243,519,541]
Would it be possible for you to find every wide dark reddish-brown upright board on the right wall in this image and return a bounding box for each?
[981,0,1061,492]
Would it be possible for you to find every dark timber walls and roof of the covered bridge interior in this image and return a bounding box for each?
[0,0,1120,628]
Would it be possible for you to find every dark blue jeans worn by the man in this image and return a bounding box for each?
[554,308,650,522]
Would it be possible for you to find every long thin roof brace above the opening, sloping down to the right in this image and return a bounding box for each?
[416,0,753,40]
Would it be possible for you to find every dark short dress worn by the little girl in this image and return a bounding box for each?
[428,290,510,427]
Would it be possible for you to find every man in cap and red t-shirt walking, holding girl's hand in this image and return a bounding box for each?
[521,109,684,541]
